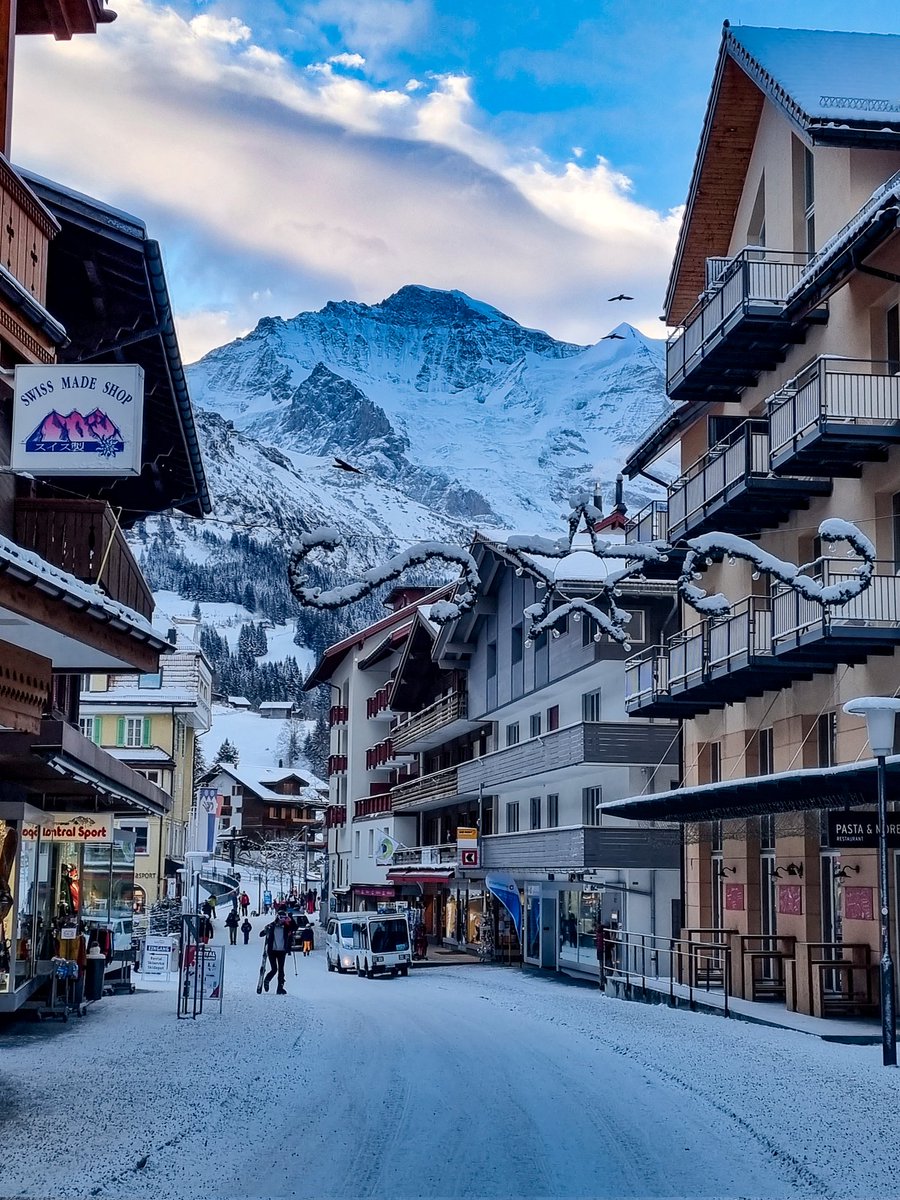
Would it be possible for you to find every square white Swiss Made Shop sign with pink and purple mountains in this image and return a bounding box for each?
[10,364,144,475]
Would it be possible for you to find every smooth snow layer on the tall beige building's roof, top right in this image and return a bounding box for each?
[727,25,900,124]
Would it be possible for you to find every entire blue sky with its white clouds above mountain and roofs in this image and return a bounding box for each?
[13,0,900,360]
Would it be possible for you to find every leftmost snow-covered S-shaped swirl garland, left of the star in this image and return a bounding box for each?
[288,527,480,625]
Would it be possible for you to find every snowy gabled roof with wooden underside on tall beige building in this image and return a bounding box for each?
[665,22,900,325]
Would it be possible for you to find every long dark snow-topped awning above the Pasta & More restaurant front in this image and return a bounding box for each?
[600,755,900,822]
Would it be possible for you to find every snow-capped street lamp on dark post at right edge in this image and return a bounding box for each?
[844,696,900,1067]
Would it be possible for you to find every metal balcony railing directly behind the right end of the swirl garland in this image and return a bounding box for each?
[772,562,900,662]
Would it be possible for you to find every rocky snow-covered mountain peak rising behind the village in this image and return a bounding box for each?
[188,286,668,539]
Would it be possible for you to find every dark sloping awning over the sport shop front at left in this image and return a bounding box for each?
[0,721,172,816]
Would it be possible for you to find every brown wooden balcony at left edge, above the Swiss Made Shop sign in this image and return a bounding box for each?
[0,155,65,364]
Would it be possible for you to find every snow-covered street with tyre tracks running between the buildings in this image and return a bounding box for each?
[0,918,900,1200]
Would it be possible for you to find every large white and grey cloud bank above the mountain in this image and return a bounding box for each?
[14,0,677,360]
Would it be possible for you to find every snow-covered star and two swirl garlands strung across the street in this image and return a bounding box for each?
[288,496,875,650]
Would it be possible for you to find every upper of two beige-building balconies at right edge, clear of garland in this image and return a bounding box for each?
[769,356,900,478]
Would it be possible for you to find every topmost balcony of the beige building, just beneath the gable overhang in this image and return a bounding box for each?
[666,247,828,401]
